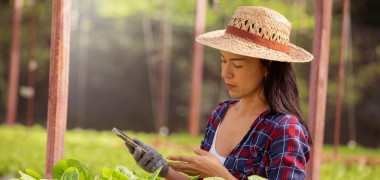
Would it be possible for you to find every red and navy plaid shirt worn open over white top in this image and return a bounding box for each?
[201,100,310,180]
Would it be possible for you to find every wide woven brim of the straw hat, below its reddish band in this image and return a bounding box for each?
[196,29,313,63]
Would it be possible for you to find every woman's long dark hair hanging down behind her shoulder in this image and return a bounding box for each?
[260,60,312,144]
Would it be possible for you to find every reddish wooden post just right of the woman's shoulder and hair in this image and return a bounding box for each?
[306,0,332,180]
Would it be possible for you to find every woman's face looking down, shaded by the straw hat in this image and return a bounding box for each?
[220,51,267,98]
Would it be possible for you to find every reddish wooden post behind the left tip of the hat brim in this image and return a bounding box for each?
[189,0,207,136]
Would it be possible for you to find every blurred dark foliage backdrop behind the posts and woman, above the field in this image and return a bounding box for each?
[0,0,380,147]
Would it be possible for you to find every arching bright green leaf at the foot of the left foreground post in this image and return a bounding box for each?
[52,159,92,180]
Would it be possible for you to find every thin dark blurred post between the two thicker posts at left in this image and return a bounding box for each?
[26,0,37,127]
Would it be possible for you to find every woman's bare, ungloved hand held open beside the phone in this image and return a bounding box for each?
[167,148,235,179]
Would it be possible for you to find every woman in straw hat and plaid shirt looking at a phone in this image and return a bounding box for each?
[128,7,313,179]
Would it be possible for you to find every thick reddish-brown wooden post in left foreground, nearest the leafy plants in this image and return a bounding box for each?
[45,0,71,179]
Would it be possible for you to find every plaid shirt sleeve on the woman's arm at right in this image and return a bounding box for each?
[266,116,310,180]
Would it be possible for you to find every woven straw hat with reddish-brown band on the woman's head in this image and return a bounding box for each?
[196,6,313,62]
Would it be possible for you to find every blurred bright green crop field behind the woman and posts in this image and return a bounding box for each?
[0,125,380,180]
